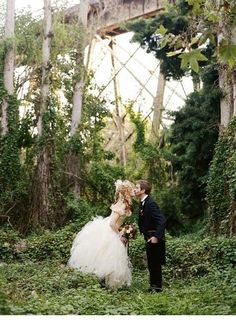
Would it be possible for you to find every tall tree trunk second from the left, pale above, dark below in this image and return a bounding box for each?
[30,0,52,228]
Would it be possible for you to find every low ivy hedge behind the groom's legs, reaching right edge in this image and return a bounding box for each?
[129,234,236,278]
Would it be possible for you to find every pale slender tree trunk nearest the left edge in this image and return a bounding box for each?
[1,0,15,135]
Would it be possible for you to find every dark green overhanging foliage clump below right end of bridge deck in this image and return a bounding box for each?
[127,0,216,82]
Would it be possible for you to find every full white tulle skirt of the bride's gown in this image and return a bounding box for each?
[68,216,131,289]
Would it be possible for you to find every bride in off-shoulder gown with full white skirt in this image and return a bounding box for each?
[68,180,134,289]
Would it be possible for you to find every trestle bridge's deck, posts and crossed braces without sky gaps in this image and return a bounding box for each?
[66,0,192,166]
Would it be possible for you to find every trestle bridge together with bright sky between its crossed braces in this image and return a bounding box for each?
[66,0,191,165]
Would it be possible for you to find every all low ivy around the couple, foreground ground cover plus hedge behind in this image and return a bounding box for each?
[0,225,236,315]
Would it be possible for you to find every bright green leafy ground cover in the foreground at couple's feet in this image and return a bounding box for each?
[0,260,236,315]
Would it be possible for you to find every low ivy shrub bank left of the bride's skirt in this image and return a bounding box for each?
[0,200,102,263]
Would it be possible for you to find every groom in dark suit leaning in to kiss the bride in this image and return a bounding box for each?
[134,180,166,293]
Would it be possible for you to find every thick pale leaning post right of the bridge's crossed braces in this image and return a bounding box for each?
[150,72,166,143]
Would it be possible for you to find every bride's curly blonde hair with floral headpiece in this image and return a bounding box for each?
[115,180,134,214]
